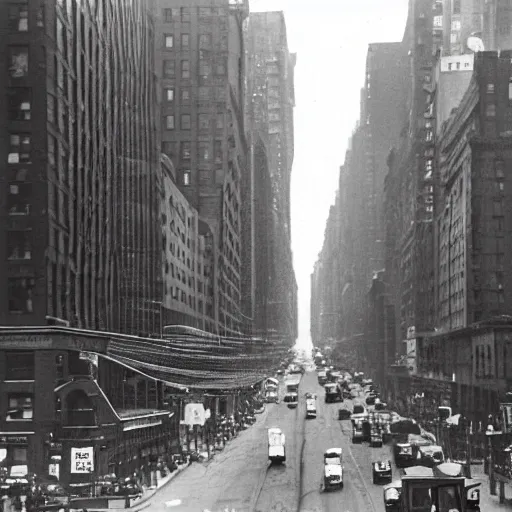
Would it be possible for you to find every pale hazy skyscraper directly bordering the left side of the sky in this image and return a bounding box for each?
[246,12,297,341]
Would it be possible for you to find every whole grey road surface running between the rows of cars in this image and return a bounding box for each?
[146,372,396,512]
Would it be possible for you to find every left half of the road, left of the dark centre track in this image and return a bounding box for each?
[148,372,304,512]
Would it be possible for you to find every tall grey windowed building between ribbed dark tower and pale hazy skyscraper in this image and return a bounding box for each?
[154,0,248,334]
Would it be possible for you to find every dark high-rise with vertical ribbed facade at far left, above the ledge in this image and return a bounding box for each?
[0,0,161,334]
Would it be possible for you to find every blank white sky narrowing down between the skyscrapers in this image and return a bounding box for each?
[249,0,407,345]
